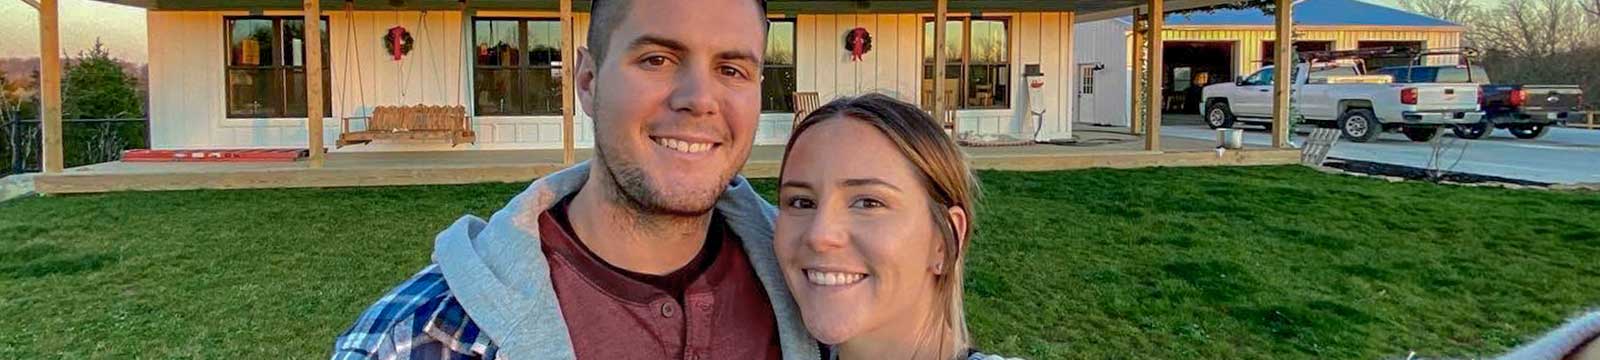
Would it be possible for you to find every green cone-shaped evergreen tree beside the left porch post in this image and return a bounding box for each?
[61,40,144,118]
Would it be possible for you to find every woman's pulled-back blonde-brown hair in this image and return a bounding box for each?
[778,93,979,354]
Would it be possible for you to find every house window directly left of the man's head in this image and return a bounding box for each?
[472,18,563,115]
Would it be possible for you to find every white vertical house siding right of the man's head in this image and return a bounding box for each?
[796,13,1075,138]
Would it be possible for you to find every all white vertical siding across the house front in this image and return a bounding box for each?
[147,11,1077,150]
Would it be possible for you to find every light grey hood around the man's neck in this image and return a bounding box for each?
[434,162,821,358]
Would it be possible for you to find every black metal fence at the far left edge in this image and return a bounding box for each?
[0,115,150,176]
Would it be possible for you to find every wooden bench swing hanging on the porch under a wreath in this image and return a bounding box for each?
[338,106,477,147]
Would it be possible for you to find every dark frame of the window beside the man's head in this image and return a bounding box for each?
[467,16,571,117]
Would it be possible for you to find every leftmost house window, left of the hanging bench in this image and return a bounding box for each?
[224,16,333,118]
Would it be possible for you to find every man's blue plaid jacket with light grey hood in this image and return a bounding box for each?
[334,163,821,358]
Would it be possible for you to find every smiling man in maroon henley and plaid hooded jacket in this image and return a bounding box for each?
[333,0,819,358]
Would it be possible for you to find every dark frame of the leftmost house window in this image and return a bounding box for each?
[222,14,333,118]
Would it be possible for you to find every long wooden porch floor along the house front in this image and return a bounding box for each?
[32,131,1299,194]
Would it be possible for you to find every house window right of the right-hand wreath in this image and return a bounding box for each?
[922,18,1011,109]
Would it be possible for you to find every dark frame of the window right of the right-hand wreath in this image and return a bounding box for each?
[920,14,1018,110]
